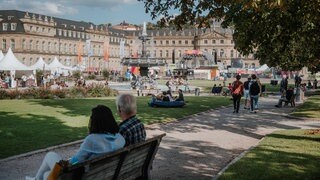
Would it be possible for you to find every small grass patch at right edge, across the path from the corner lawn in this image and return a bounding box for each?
[291,95,320,120]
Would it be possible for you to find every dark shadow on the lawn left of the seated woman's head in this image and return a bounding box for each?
[0,111,88,159]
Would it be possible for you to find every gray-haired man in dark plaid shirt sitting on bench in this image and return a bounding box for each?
[116,94,146,146]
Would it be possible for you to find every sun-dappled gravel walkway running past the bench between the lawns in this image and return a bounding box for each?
[0,97,320,180]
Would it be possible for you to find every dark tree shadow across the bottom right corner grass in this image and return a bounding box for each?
[219,148,320,180]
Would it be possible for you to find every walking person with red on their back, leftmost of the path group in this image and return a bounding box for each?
[231,74,243,113]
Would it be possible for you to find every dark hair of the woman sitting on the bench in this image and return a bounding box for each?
[89,105,119,134]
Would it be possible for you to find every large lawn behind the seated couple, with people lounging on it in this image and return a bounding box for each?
[0,96,231,159]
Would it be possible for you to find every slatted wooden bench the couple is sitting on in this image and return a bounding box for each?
[58,134,165,180]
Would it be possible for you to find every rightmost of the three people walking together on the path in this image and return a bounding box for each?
[249,74,260,113]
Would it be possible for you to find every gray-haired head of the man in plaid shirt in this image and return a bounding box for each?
[116,94,137,114]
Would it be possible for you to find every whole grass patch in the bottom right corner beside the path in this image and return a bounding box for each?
[219,130,320,180]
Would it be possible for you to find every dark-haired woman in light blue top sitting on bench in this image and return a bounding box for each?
[26,105,125,180]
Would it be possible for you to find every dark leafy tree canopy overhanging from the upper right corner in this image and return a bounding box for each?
[138,0,320,72]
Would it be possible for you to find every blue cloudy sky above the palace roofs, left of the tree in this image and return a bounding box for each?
[0,0,156,25]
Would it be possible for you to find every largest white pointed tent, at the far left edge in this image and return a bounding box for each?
[0,48,33,87]
